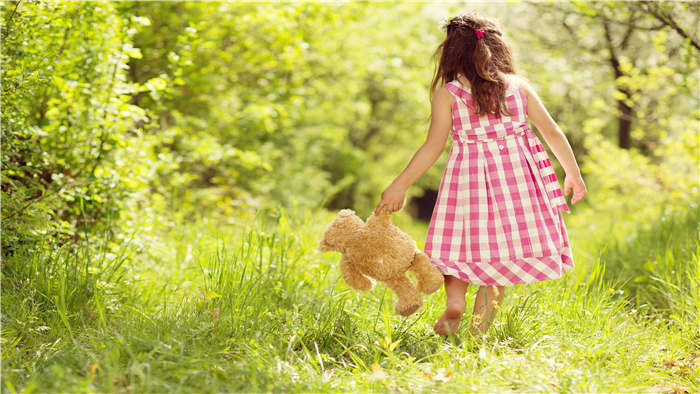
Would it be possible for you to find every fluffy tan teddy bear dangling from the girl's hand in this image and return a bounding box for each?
[318,209,443,316]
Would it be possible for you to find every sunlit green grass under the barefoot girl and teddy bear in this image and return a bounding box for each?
[2,205,700,393]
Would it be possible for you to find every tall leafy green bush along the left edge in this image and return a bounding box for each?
[0,1,143,249]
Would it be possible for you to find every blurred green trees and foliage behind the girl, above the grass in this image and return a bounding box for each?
[2,1,700,249]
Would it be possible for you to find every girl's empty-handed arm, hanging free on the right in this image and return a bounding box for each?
[521,79,586,204]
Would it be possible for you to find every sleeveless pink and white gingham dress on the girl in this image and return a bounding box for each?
[424,75,574,286]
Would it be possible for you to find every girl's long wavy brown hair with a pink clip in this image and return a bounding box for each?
[430,12,515,116]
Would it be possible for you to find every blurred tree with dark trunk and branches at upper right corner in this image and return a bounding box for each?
[531,1,699,149]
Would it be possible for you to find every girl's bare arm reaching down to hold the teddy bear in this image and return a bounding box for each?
[374,86,453,214]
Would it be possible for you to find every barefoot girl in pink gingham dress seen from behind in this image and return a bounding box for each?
[375,13,586,336]
